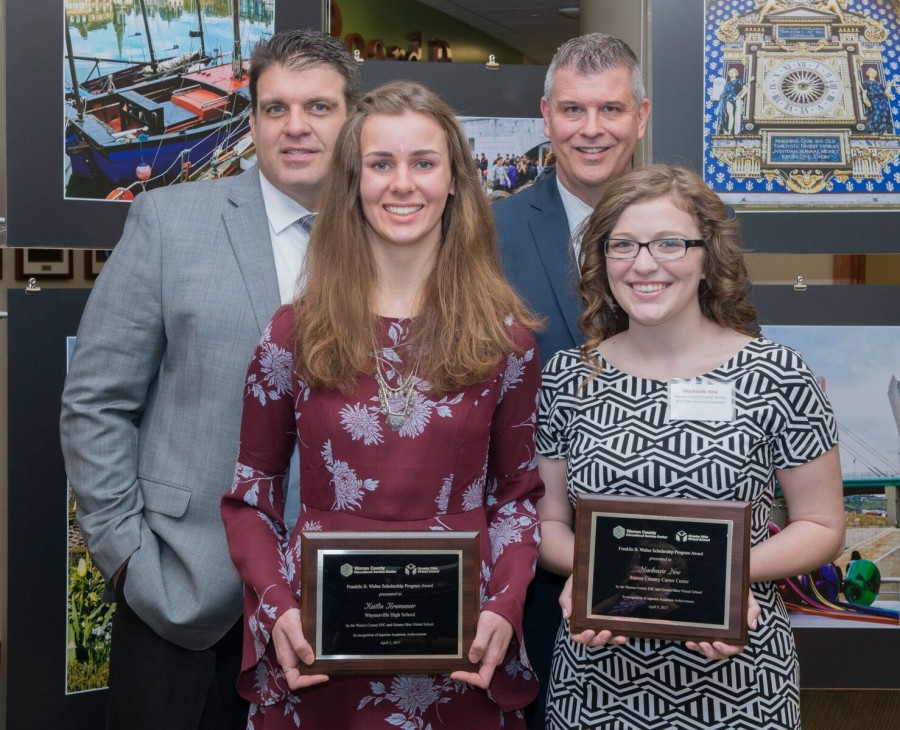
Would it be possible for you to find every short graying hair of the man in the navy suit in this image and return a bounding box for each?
[544,33,647,104]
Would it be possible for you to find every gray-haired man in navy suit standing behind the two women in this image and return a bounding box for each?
[493,33,650,729]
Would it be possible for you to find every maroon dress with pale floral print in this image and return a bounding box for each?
[222,307,543,730]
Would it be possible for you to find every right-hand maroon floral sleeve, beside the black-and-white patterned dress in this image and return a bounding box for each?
[482,328,544,632]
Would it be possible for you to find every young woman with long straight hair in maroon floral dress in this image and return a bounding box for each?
[222,82,543,730]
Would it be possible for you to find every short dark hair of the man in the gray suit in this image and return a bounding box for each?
[250,29,359,114]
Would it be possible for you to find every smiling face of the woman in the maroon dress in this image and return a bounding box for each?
[359,112,454,260]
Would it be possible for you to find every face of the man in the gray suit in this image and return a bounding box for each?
[250,64,347,210]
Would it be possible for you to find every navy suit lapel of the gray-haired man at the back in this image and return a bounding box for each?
[528,174,582,342]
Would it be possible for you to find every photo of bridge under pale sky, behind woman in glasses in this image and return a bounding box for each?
[763,325,900,630]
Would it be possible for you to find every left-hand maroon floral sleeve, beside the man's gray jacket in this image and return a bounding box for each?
[222,307,298,661]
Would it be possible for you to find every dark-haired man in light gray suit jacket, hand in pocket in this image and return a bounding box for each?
[61,31,359,730]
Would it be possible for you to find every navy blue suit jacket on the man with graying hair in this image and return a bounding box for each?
[491,172,583,365]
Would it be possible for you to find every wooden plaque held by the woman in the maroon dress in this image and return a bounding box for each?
[301,532,480,674]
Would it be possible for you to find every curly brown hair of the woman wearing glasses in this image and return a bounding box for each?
[579,165,760,359]
